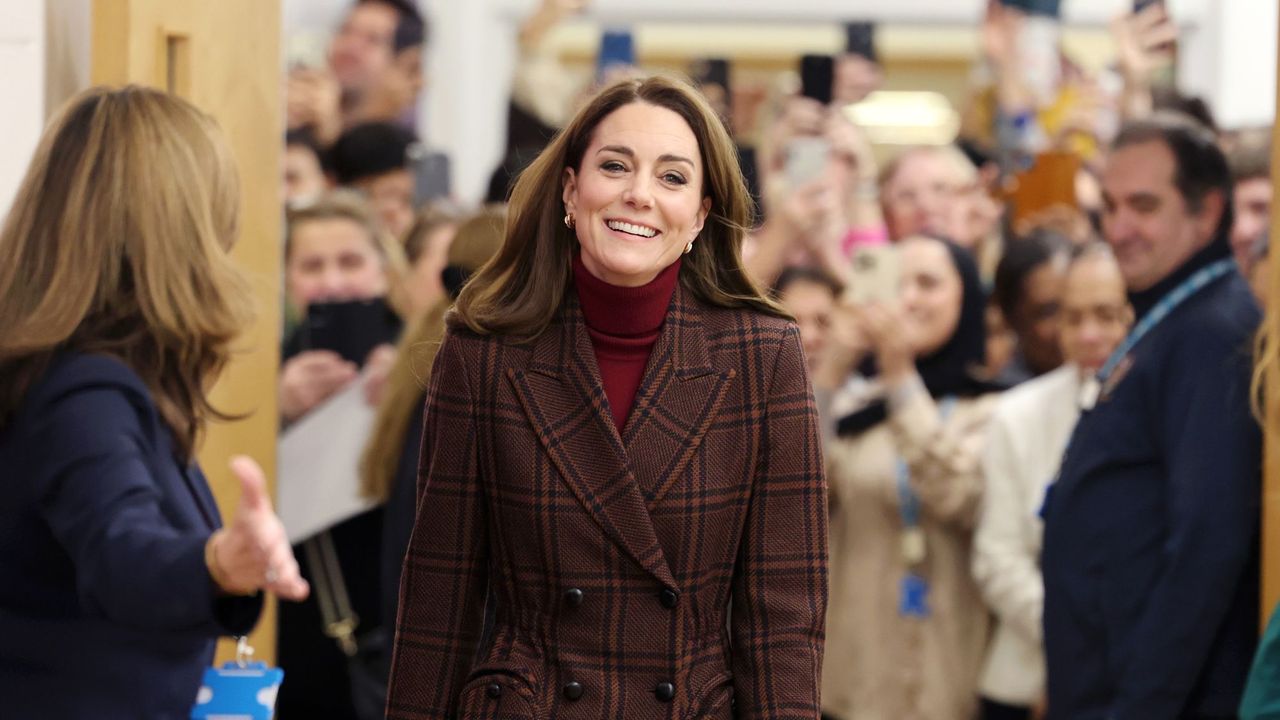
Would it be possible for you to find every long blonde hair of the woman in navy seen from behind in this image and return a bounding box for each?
[0,86,250,459]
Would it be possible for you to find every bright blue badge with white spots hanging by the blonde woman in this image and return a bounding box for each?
[191,638,284,720]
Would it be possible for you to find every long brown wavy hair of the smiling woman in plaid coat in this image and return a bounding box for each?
[449,76,791,336]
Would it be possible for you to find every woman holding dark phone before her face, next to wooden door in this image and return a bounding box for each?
[278,192,403,719]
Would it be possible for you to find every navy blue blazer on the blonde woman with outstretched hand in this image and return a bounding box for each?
[0,354,262,719]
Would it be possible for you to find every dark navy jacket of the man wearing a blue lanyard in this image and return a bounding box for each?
[1043,241,1261,720]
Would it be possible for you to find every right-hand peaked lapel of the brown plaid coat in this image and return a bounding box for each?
[622,284,737,510]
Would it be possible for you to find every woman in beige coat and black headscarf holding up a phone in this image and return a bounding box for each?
[822,237,996,720]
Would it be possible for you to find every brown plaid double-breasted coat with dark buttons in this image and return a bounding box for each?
[388,281,827,720]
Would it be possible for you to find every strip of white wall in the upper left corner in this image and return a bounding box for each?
[0,0,45,217]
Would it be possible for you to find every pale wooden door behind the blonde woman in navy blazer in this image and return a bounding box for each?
[90,0,283,660]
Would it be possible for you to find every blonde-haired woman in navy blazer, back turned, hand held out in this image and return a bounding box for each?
[0,87,307,717]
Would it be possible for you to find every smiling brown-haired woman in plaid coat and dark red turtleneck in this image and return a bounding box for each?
[388,78,827,719]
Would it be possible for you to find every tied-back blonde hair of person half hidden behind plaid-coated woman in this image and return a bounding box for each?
[360,205,507,502]
